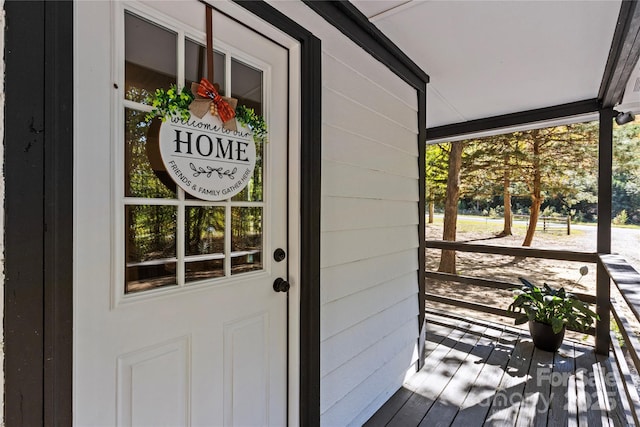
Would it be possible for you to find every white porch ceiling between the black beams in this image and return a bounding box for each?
[352,0,640,128]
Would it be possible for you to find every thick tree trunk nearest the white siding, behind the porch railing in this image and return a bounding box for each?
[438,141,463,274]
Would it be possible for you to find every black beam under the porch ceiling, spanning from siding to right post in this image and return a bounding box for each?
[427,99,600,141]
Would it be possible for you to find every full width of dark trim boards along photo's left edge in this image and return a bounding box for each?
[4,1,73,425]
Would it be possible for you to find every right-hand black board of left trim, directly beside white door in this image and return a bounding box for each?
[44,1,74,425]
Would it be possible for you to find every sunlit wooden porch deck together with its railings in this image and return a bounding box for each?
[366,240,640,427]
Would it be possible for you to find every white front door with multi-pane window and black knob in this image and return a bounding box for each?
[73,0,290,426]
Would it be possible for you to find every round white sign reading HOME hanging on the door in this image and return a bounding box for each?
[159,114,256,201]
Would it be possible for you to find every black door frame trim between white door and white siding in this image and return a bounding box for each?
[238,1,322,426]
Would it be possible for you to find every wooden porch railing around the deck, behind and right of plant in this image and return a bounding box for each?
[425,240,640,425]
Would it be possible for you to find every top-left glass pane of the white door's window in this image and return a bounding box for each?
[124,13,178,103]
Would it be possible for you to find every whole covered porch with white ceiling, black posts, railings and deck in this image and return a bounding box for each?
[355,1,640,427]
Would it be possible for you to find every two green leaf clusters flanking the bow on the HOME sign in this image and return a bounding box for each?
[145,84,267,142]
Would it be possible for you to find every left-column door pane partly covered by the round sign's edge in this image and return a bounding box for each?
[124,108,176,198]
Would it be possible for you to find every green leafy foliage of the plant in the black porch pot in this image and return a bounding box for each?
[508,277,599,334]
